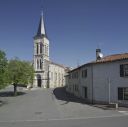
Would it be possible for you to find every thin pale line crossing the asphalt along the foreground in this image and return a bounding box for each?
[0,114,128,123]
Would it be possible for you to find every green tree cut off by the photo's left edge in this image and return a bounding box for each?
[0,50,7,89]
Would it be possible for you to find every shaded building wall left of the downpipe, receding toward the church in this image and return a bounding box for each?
[66,66,92,101]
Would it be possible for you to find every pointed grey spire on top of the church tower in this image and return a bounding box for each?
[37,12,46,36]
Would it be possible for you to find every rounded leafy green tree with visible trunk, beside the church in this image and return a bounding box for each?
[7,58,34,95]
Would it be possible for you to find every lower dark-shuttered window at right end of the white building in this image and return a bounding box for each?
[118,87,128,100]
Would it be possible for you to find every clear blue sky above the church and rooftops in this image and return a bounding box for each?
[0,0,128,67]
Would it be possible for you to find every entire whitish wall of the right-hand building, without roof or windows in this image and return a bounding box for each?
[66,60,128,104]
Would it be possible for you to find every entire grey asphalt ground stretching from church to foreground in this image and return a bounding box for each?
[0,88,128,127]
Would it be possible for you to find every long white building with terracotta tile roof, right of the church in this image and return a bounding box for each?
[66,49,128,105]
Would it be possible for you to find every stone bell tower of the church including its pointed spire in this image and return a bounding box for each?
[33,13,50,88]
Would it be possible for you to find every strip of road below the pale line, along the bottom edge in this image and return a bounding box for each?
[0,116,128,127]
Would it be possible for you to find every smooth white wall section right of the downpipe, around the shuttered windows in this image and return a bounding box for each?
[93,60,128,102]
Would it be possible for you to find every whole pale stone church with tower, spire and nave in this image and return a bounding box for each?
[33,14,67,88]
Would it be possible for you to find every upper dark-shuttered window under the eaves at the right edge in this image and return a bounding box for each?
[120,64,128,77]
